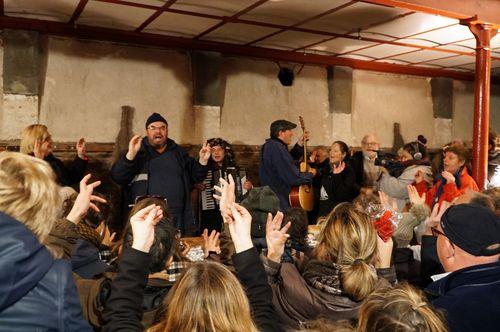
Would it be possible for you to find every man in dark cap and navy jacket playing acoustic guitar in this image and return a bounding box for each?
[259,120,316,211]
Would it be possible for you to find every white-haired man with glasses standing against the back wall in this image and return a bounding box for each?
[352,134,381,188]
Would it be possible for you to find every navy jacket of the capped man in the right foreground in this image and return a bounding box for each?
[426,261,500,332]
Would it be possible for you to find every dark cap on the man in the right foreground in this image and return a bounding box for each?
[441,204,500,256]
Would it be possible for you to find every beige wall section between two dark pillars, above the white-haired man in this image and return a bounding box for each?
[352,70,436,147]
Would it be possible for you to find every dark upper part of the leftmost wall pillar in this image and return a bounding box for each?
[3,29,40,95]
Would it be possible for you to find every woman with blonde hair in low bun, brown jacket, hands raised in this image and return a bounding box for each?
[265,203,395,328]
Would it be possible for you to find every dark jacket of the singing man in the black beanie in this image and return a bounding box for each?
[111,137,208,235]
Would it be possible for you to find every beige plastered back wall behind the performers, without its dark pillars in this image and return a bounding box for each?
[0,37,500,147]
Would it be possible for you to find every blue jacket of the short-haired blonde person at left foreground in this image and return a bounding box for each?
[0,212,92,331]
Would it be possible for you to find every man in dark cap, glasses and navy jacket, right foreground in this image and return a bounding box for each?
[427,204,500,331]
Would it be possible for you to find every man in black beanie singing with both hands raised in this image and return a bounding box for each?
[111,113,211,235]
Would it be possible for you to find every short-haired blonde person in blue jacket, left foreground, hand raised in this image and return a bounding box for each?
[0,152,100,331]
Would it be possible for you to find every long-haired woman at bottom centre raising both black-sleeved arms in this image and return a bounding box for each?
[104,176,280,332]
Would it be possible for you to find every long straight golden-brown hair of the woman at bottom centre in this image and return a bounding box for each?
[148,262,257,332]
